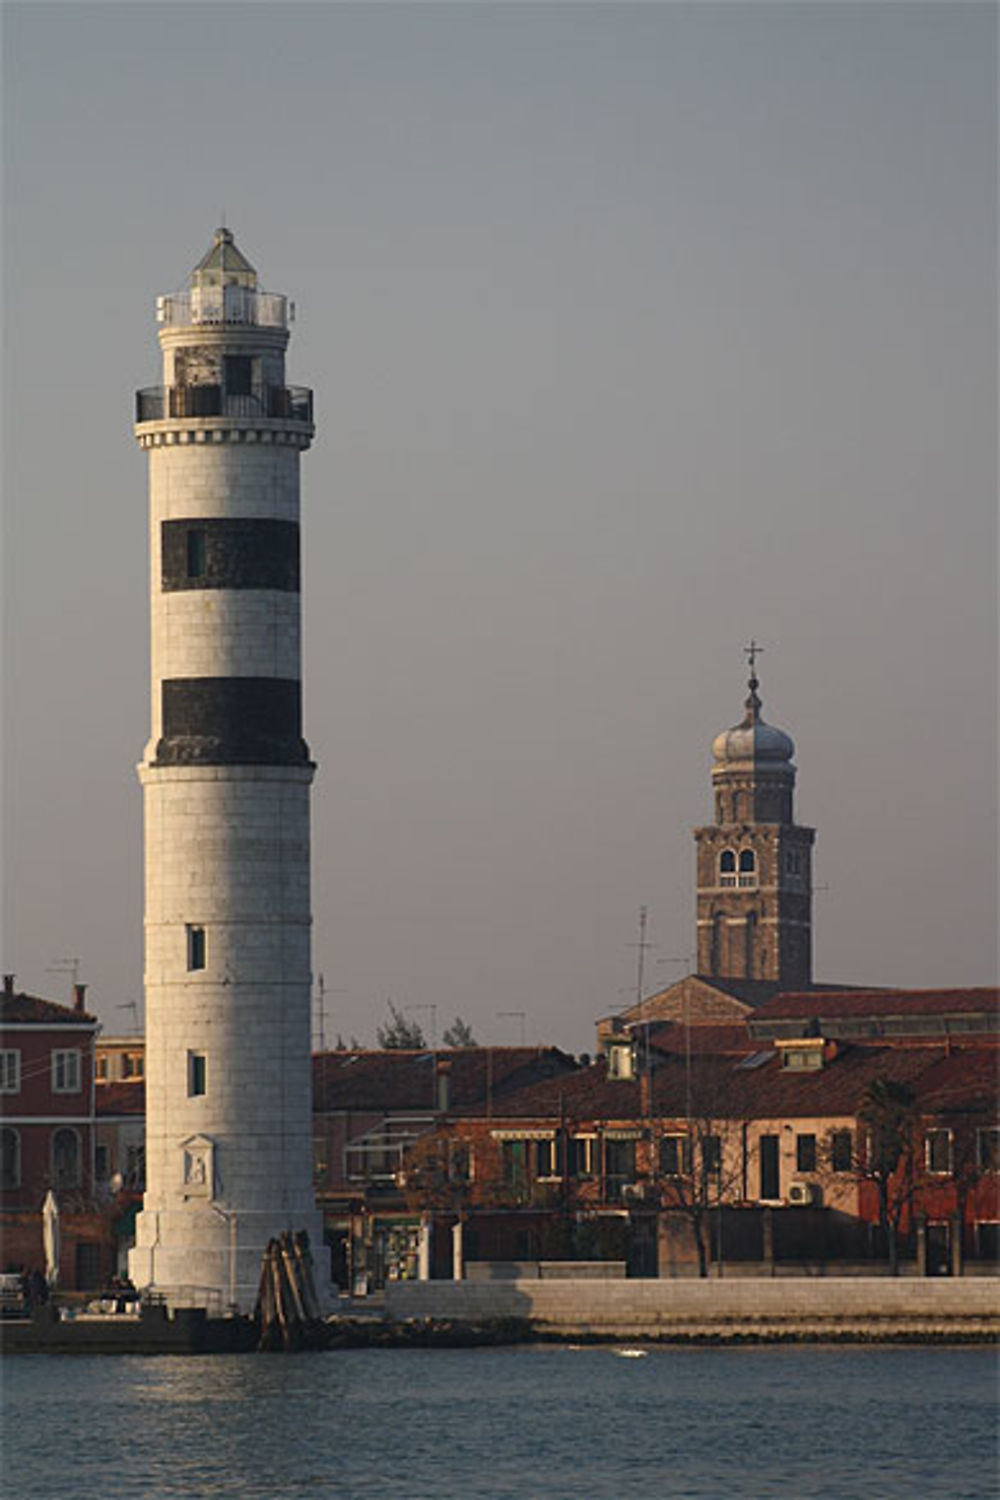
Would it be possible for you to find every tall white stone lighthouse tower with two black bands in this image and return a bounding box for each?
[130,230,325,1310]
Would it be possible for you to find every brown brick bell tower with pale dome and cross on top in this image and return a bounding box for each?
[694,641,816,989]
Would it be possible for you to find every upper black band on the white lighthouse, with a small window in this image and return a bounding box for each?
[160,518,300,594]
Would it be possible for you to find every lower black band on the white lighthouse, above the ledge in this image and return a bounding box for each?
[154,677,309,767]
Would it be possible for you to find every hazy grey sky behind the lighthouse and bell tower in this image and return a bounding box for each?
[1,3,997,1050]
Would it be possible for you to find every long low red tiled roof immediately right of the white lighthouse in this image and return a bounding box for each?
[312,1047,576,1113]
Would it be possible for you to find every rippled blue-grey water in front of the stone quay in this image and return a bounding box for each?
[3,1346,997,1500]
